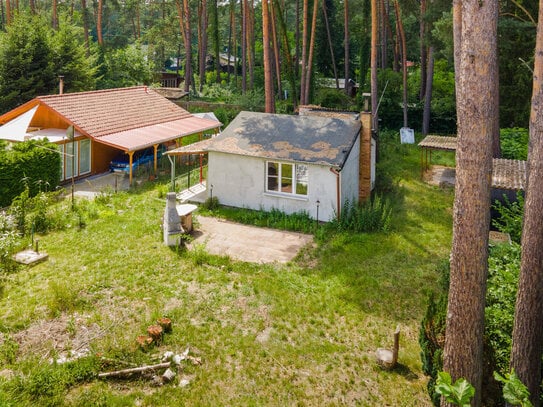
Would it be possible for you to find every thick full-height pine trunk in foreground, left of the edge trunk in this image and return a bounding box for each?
[442,0,498,406]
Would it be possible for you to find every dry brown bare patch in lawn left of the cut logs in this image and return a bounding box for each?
[7,314,105,360]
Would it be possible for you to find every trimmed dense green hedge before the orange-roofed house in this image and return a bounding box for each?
[0,140,61,207]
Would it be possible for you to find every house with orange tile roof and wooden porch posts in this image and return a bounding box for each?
[0,86,221,182]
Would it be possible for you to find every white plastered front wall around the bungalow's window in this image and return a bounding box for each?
[207,151,340,221]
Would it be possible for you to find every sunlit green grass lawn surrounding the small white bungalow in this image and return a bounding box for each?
[0,136,453,406]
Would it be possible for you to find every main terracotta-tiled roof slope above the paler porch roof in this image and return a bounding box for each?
[37,86,191,138]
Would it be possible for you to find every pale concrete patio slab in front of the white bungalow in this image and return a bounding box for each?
[188,216,313,263]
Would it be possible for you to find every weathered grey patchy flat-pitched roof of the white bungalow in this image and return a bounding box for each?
[208,112,361,168]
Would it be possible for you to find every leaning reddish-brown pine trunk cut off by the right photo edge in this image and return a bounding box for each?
[511,0,543,407]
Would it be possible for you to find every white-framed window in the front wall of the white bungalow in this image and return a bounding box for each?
[266,161,308,195]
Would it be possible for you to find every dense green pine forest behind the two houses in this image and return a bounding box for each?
[0,0,537,133]
